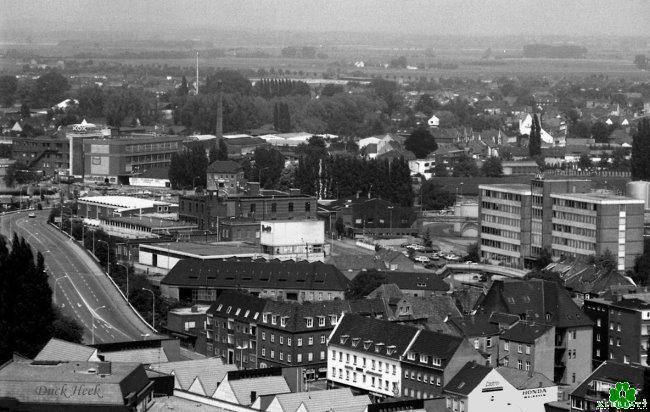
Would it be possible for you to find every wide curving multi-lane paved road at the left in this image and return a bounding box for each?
[0,211,154,343]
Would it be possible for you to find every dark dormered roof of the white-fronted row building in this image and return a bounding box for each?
[330,313,418,359]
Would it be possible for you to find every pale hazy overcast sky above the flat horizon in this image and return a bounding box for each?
[0,0,650,36]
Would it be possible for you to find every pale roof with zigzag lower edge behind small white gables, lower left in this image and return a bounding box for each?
[149,358,237,396]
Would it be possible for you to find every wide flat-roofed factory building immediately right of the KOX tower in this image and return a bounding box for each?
[83,134,184,184]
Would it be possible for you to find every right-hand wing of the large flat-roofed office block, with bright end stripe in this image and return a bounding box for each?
[551,193,644,270]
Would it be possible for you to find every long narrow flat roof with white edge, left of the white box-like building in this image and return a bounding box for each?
[140,242,262,258]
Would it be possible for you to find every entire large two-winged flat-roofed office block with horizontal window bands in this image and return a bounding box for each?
[479,179,643,270]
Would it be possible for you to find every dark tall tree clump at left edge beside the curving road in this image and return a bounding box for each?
[0,233,82,362]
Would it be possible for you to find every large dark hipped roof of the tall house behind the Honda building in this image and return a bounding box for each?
[477,279,592,328]
